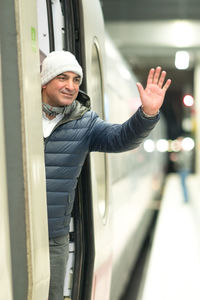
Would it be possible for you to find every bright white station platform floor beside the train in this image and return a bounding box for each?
[137,174,200,300]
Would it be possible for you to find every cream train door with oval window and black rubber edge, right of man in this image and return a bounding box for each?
[64,0,112,300]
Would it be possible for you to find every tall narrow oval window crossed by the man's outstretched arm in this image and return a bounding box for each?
[91,40,107,219]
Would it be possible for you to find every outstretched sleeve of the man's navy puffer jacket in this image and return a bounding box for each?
[90,107,160,153]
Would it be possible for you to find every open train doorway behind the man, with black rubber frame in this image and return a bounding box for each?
[37,0,94,299]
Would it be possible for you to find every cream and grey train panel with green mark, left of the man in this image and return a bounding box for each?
[0,0,49,300]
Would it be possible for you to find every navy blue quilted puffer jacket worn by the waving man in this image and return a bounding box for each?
[45,92,159,238]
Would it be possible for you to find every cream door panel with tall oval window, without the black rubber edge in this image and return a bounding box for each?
[78,0,112,300]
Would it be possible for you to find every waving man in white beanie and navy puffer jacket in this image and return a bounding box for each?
[41,51,171,300]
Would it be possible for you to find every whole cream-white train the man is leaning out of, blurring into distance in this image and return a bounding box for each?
[0,0,166,300]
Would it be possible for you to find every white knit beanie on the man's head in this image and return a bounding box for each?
[41,51,83,86]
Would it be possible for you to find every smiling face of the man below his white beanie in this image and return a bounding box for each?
[42,72,80,106]
